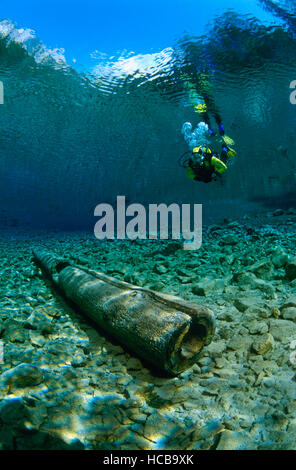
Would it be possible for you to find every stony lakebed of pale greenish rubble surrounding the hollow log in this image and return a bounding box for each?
[0,209,296,450]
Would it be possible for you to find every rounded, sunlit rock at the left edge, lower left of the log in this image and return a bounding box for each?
[0,364,44,390]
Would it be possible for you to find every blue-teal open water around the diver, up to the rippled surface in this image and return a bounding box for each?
[0,0,296,230]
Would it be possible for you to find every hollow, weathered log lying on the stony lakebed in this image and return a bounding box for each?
[34,251,215,375]
